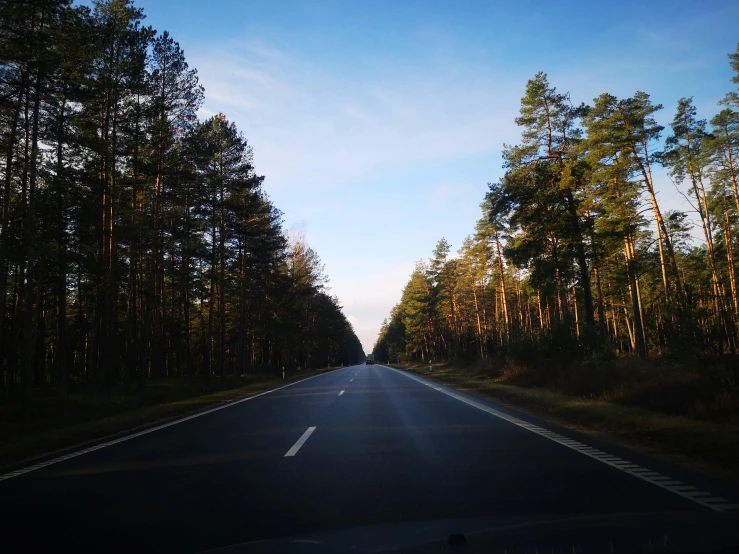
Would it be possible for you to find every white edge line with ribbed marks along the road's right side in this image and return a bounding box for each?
[383,366,739,512]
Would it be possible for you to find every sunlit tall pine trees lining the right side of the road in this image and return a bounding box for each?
[374,47,739,362]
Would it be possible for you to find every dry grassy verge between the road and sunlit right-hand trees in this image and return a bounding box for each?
[393,363,739,483]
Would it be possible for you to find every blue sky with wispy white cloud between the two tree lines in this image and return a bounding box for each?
[136,0,739,351]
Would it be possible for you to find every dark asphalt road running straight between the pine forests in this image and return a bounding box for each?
[0,365,732,552]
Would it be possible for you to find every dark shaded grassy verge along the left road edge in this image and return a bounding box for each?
[0,368,337,469]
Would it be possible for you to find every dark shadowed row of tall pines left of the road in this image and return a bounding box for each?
[0,0,363,414]
